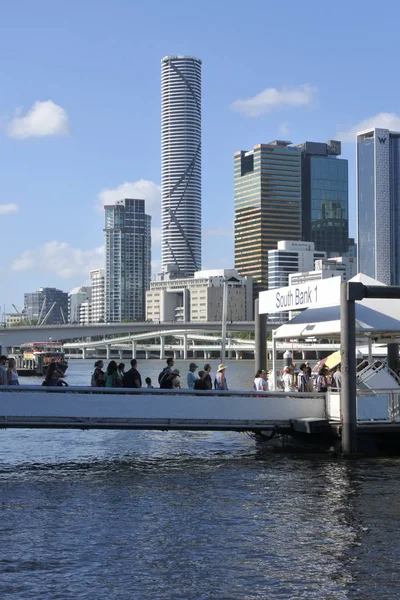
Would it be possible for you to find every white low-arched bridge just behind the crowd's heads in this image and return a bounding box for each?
[64,329,339,360]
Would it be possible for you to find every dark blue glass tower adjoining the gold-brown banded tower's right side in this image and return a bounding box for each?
[297,140,349,255]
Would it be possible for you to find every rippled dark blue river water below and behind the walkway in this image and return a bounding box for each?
[0,361,400,600]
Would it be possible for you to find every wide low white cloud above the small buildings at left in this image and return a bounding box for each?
[11,241,104,279]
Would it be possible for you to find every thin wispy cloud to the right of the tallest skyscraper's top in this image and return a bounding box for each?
[231,84,316,117]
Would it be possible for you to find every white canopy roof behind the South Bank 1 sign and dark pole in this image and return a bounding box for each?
[275,273,400,339]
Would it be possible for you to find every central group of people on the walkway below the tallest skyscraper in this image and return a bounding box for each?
[91,358,228,390]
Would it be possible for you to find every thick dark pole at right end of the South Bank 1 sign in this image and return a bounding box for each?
[340,283,358,454]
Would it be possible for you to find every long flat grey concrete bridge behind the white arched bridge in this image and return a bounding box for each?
[0,321,260,348]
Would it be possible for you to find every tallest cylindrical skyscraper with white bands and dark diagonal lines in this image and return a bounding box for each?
[161,56,201,277]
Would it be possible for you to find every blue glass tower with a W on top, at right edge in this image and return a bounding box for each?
[357,128,400,285]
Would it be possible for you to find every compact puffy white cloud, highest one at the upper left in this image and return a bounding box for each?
[7,100,69,139]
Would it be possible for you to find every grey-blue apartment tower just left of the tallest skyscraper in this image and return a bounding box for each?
[104,198,151,322]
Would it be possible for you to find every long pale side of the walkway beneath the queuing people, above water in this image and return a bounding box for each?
[0,386,326,432]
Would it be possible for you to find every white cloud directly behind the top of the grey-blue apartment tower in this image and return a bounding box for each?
[97,179,161,220]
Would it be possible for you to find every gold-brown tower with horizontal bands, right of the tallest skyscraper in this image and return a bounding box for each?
[235,140,301,297]
